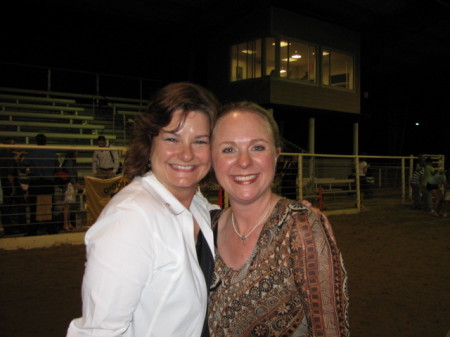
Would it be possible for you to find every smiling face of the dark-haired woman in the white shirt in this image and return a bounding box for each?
[150,110,211,201]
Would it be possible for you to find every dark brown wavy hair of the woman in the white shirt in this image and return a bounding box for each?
[124,82,219,179]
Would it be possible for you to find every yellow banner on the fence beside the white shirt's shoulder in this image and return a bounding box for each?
[84,176,129,226]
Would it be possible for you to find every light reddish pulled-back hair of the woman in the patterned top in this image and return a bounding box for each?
[216,101,283,148]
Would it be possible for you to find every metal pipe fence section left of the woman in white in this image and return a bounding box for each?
[0,144,126,236]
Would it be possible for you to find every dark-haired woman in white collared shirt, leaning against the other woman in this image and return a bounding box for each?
[67,83,218,337]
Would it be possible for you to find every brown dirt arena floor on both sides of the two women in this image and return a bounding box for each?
[0,200,450,337]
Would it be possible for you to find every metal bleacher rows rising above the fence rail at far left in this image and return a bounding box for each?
[0,87,117,145]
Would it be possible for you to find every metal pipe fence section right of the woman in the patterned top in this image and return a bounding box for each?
[274,153,445,213]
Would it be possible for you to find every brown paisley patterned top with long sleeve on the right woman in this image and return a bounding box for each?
[208,199,349,337]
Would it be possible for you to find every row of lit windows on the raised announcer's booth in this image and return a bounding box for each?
[230,37,355,90]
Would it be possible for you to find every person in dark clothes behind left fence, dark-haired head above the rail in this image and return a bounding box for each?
[22,133,58,235]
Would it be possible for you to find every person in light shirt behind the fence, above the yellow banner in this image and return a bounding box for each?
[92,136,120,179]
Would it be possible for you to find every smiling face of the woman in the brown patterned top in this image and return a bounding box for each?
[212,111,279,203]
